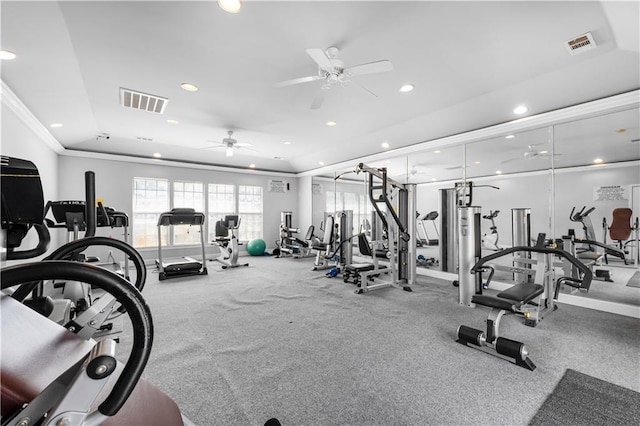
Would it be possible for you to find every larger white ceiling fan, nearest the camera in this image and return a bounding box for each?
[275,46,393,109]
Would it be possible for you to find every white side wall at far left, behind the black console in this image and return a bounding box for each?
[0,102,58,262]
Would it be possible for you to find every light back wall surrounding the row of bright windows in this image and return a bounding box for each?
[58,156,298,259]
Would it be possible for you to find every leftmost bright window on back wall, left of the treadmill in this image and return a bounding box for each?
[131,178,169,247]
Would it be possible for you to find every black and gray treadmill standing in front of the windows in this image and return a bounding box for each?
[156,208,207,281]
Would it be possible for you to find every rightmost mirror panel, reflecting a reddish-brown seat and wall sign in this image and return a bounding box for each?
[553,109,640,306]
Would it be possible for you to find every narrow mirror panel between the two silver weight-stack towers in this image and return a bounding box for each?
[416,146,464,273]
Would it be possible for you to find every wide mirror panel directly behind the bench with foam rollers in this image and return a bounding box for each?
[466,127,555,284]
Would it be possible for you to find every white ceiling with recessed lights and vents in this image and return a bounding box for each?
[0,0,640,172]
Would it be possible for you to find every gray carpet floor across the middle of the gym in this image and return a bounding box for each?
[120,257,640,425]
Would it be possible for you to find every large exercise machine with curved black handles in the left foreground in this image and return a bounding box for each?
[0,156,190,426]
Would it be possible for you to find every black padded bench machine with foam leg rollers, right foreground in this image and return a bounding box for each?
[457,234,592,371]
